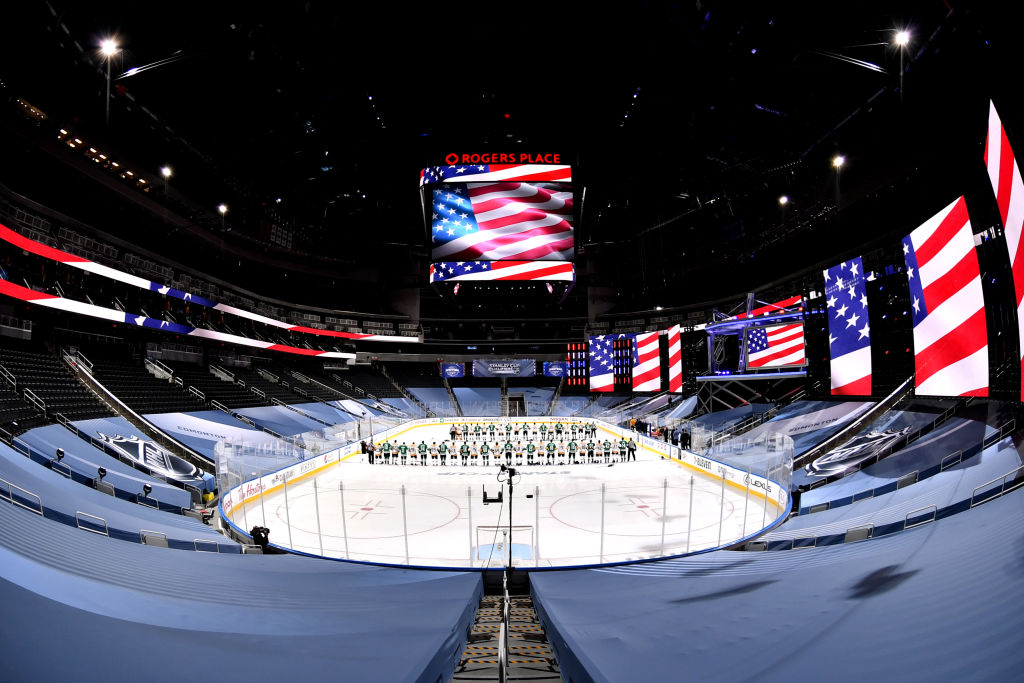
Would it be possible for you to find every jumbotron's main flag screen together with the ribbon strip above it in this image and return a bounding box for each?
[420,164,575,263]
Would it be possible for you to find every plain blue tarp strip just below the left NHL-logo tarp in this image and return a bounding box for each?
[14,425,191,508]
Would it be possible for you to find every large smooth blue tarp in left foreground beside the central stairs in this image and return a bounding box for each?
[0,501,482,683]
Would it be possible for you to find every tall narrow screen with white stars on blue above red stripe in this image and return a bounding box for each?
[824,256,871,396]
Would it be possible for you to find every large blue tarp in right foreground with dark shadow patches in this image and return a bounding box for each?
[530,490,1024,683]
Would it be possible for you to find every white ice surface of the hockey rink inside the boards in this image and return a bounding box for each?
[232,425,780,567]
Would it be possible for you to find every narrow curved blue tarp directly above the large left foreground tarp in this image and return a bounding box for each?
[0,443,241,553]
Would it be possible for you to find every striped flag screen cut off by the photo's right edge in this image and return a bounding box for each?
[985,102,1024,399]
